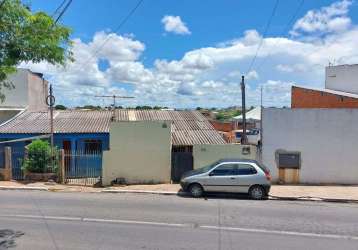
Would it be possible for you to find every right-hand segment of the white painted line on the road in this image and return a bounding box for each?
[199,225,358,240]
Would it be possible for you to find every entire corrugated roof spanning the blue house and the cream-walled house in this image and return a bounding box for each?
[0,109,226,145]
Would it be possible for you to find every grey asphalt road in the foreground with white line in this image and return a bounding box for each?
[0,191,358,250]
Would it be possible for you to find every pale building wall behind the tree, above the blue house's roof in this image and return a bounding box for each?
[0,69,48,110]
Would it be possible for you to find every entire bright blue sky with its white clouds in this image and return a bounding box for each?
[24,0,358,107]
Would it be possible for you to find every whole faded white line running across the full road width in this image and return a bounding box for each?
[0,214,358,240]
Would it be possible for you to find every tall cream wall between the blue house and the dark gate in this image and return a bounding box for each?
[102,121,171,186]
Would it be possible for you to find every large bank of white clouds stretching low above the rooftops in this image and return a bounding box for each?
[21,1,358,108]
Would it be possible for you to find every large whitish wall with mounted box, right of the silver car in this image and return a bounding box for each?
[262,108,358,184]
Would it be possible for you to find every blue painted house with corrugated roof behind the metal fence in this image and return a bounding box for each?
[0,110,112,178]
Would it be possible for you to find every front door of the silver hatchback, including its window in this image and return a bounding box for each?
[204,163,238,192]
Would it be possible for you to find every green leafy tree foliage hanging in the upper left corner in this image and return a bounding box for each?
[0,0,73,101]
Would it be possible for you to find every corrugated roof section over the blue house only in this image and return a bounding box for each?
[0,111,112,134]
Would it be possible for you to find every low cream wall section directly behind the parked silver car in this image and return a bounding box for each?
[193,144,257,169]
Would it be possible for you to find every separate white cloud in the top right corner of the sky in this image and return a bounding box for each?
[290,0,352,36]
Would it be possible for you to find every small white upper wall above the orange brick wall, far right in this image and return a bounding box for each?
[326,64,358,94]
